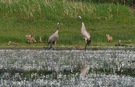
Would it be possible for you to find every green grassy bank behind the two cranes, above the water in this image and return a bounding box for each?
[0,0,135,47]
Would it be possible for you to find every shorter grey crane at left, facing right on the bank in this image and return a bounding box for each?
[48,22,60,49]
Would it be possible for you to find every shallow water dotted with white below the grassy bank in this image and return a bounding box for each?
[0,49,135,87]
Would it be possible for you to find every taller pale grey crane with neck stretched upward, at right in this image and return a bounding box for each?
[79,16,91,50]
